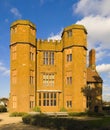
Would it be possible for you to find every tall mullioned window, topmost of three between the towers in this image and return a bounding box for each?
[43,51,54,65]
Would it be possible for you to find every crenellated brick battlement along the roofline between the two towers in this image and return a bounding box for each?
[37,39,61,44]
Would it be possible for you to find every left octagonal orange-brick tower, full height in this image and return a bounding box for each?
[9,20,36,112]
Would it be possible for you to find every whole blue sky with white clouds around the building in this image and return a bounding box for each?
[0,0,110,101]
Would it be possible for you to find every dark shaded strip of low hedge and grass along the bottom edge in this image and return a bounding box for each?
[23,115,110,130]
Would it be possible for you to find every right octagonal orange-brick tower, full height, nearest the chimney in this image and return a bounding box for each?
[62,24,87,112]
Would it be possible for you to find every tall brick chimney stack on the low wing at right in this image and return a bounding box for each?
[89,49,96,70]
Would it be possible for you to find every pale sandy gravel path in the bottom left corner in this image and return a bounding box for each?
[0,113,50,130]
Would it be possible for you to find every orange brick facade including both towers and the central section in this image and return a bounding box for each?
[9,20,102,112]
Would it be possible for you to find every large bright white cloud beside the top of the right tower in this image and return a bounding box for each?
[77,16,110,49]
